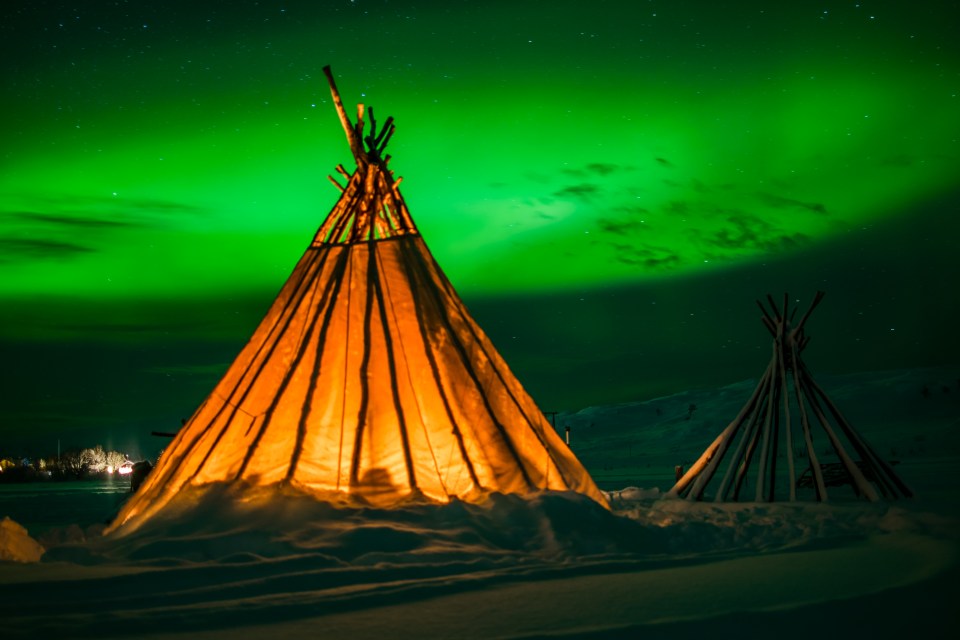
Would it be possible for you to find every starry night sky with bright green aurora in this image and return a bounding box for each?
[0,0,960,457]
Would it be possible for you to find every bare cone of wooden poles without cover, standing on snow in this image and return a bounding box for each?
[668,291,912,502]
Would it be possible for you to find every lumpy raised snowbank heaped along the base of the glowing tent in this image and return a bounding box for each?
[46,485,947,574]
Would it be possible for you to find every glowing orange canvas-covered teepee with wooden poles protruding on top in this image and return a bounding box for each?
[111,67,605,530]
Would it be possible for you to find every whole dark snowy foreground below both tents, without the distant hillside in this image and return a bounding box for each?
[0,487,960,640]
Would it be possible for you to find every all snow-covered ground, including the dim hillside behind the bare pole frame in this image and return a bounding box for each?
[0,368,960,638]
